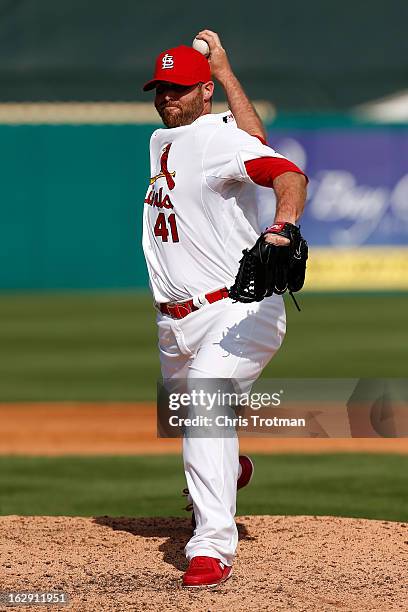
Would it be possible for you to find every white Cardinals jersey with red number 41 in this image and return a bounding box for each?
[143,113,282,303]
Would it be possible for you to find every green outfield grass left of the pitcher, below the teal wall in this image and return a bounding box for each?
[0,293,159,401]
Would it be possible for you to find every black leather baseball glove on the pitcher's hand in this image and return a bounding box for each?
[229,223,308,310]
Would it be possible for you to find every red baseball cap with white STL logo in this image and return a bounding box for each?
[143,45,211,91]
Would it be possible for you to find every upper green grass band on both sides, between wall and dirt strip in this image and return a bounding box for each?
[0,292,408,401]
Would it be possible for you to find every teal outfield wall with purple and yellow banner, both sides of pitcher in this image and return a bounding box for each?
[0,115,408,291]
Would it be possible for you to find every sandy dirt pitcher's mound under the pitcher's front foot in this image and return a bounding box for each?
[0,516,408,612]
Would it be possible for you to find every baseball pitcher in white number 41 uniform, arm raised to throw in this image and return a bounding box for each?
[143,30,307,587]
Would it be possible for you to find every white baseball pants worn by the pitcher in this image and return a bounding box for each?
[157,295,286,565]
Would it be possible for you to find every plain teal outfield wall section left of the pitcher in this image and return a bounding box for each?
[0,125,153,289]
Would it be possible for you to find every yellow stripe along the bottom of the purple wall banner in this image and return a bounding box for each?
[305,247,408,291]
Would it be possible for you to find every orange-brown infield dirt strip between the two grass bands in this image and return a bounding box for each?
[0,402,408,456]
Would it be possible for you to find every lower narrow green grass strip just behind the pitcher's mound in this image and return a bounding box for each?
[0,454,408,522]
